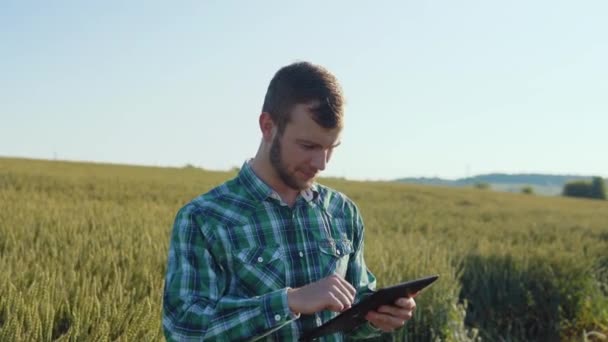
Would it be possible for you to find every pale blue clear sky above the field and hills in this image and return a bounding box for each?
[0,0,608,180]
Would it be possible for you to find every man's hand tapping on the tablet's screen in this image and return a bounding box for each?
[287,274,357,315]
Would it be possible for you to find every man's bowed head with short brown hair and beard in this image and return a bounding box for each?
[260,62,344,190]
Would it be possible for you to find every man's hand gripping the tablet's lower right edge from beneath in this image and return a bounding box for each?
[365,296,416,332]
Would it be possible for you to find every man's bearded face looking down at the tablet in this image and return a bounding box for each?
[270,104,341,190]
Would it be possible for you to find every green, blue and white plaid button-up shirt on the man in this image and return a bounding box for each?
[163,162,379,341]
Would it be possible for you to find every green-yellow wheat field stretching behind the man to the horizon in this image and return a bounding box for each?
[0,158,608,341]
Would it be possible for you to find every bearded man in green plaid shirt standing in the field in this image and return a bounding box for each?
[163,62,416,341]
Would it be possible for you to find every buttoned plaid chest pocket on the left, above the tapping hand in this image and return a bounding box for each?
[233,246,285,296]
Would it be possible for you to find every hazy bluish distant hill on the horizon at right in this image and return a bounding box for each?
[395,173,604,196]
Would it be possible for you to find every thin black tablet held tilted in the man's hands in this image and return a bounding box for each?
[300,275,439,341]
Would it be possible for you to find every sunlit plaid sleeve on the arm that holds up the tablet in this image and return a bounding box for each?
[346,205,382,340]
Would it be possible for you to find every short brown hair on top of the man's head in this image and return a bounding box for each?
[262,62,344,133]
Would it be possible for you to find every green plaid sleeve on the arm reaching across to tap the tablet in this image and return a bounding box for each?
[162,204,299,341]
